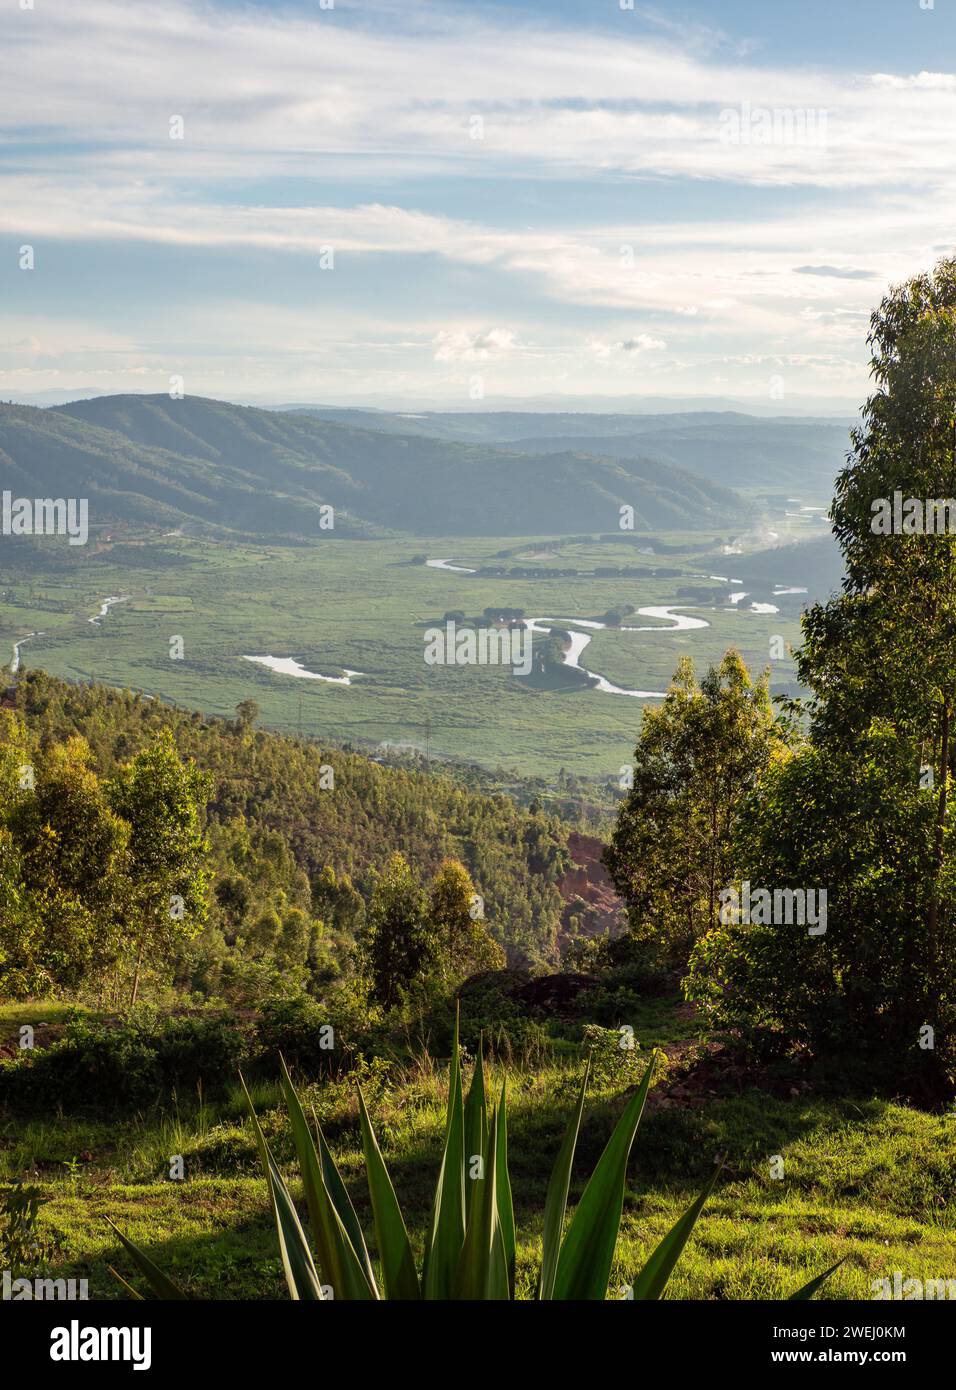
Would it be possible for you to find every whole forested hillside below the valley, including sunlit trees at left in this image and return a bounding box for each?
[0,671,570,1008]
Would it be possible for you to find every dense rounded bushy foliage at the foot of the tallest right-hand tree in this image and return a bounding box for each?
[686,724,956,1093]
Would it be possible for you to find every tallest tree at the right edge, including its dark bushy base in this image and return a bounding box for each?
[688,259,956,1102]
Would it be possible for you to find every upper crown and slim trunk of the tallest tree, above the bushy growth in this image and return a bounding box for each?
[798,259,956,1000]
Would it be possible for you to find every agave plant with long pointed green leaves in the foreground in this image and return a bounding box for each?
[110,1020,837,1301]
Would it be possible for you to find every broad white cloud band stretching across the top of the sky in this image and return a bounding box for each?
[0,0,956,189]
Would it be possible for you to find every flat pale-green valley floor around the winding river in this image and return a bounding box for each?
[0,532,813,783]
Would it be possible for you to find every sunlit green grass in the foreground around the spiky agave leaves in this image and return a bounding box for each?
[0,999,956,1298]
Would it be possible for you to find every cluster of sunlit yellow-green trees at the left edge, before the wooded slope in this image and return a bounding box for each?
[0,712,206,995]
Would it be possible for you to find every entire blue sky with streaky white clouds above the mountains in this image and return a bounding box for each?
[0,0,956,413]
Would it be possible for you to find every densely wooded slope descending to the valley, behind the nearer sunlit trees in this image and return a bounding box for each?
[9,671,571,963]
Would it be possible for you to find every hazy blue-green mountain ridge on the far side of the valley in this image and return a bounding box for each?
[0,395,744,537]
